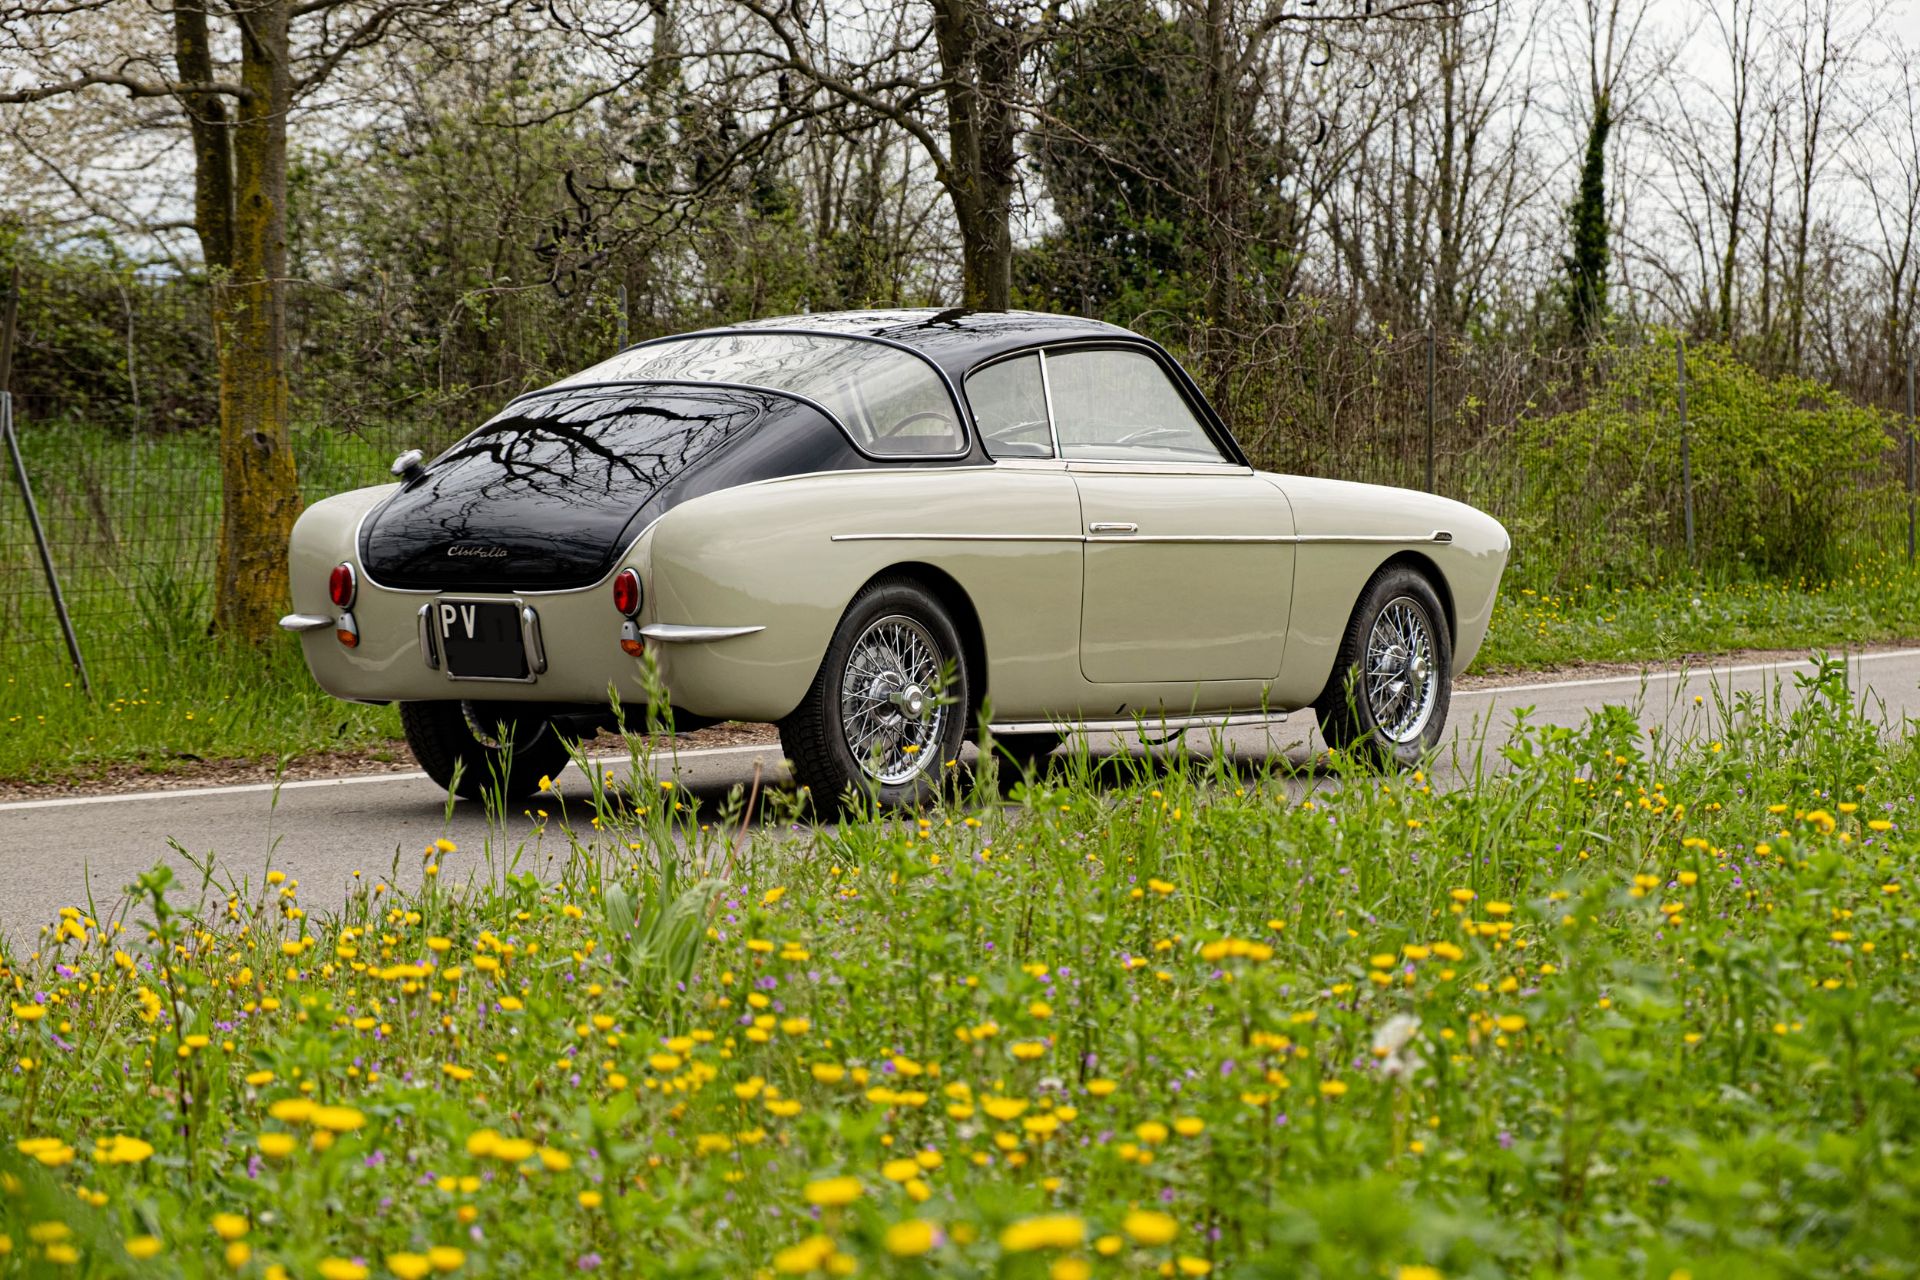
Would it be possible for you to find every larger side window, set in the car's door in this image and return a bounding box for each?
[1046,349,1227,462]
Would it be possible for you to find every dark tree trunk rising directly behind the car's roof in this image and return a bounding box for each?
[933,0,1021,311]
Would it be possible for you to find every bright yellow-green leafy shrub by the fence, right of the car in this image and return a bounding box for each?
[1509,334,1897,583]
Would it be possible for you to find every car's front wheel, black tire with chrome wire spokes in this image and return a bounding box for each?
[1313,564,1453,770]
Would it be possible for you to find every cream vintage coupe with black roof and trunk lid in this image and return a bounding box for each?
[282,311,1509,804]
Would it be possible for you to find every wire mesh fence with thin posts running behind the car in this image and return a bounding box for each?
[0,268,1910,660]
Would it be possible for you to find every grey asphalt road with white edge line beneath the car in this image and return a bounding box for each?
[0,649,1920,942]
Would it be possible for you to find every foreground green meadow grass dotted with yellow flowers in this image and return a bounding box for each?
[0,666,1920,1280]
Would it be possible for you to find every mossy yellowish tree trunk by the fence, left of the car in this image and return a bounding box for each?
[213,0,300,645]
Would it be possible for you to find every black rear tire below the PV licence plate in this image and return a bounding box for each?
[399,702,570,800]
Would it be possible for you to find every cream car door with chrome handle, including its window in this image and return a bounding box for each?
[1044,347,1294,685]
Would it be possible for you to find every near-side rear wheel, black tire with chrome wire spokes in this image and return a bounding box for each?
[780,578,973,808]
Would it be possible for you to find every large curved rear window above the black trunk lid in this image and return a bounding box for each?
[561,330,966,457]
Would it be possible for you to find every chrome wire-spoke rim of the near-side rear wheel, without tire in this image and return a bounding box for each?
[839,614,952,787]
